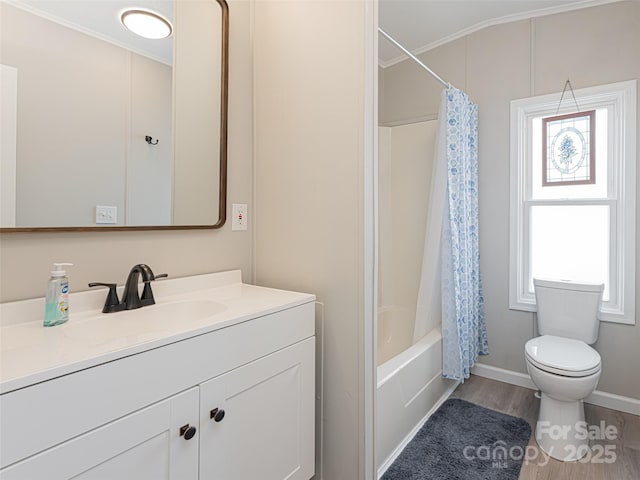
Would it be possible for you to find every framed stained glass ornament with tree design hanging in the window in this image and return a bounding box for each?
[542,110,596,187]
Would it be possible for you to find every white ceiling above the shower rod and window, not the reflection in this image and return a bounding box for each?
[378,0,618,67]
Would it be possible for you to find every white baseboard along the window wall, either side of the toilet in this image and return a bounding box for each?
[471,363,640,416]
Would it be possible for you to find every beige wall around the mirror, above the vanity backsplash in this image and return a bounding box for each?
[0,0,253,300]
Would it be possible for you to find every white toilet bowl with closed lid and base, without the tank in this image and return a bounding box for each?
[525,335,601,461]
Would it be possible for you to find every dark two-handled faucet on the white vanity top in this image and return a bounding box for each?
[89,263,168,313]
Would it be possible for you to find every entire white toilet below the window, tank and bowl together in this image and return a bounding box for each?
[525,279,604,461]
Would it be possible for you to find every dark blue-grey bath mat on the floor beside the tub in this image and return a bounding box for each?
[382,399,531,480]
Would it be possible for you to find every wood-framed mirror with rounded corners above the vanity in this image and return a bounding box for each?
[0,0,229,233]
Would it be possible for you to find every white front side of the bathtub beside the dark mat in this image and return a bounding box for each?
[376,329,458,478]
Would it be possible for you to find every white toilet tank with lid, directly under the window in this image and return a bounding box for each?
[533,278,604,345]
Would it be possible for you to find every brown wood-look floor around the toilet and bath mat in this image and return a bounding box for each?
[451,375,640,480]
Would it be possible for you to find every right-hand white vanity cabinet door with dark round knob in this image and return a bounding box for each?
[200,337,315,480]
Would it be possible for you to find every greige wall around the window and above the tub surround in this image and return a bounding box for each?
[380,1,640,398]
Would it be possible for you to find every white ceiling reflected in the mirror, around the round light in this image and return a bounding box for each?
[10,0,173,65]
